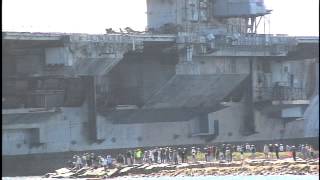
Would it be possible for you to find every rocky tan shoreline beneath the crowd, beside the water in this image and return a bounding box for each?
[45,158,319,178]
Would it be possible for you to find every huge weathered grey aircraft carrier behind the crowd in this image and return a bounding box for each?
[2,0,319,176]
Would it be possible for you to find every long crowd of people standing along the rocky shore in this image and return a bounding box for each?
[69,143,314,169]
